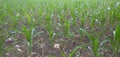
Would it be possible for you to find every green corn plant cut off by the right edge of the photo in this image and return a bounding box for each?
[110,24,120,57]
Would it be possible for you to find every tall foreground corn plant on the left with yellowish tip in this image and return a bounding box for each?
[22,13,35,57]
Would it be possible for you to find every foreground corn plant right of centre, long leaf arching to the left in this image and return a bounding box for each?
[80,28,101,57]
